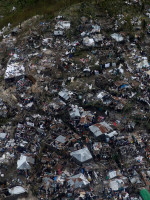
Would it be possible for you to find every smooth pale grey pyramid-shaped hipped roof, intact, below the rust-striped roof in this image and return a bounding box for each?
[70,147,92,162]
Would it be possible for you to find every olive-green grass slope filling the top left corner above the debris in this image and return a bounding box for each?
[0,0,86,28]
